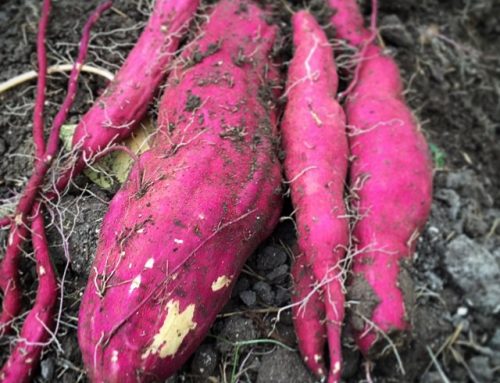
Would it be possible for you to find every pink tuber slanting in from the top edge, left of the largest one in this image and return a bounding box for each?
[67,0,200,185]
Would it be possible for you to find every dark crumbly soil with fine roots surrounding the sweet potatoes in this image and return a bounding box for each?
[0,0,500,383]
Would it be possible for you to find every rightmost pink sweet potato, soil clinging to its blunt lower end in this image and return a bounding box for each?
[330,0,432,357]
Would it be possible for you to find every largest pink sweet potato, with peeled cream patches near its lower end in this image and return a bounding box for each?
[78,0,281,383]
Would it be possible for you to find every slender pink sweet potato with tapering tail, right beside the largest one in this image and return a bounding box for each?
[281,11,349,382]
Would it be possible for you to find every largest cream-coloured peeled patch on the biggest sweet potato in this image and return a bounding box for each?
[142,300,197,359]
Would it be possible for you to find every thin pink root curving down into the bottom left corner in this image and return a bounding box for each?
[0,203,57,383]
